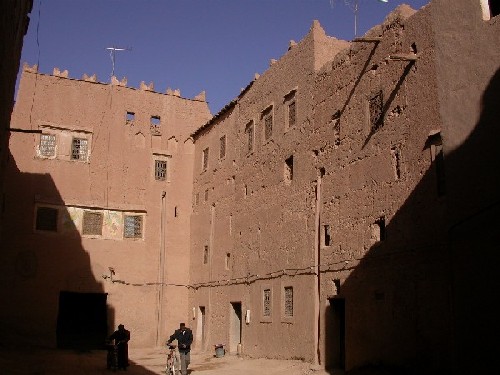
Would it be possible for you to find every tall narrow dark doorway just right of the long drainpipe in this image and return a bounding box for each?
[325,298,345,370]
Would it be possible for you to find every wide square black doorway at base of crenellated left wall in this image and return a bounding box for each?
[57,292,108,350]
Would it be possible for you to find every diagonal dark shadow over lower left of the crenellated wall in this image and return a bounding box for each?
[0,150,115,349]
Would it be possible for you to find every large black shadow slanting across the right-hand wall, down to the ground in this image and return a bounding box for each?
[325,69,500,375]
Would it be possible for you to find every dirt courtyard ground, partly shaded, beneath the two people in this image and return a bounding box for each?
[0,347,336,375]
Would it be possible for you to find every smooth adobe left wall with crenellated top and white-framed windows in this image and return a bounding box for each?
[1,68,211,347]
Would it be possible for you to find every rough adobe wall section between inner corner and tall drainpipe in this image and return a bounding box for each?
[190,22,347,362]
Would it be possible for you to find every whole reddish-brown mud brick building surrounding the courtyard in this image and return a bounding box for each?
[0,0,500,374]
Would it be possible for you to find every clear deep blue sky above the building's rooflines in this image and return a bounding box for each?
[17,0,429,114]
